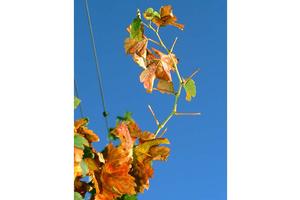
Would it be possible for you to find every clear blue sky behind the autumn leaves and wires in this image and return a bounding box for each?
[74,0,227,200]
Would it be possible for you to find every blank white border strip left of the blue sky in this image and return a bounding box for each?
[0,0,74,200]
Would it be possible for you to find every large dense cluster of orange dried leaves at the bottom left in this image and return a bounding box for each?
[74,114,170,200]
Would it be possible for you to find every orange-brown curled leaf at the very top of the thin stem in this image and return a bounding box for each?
[151,5,184,30]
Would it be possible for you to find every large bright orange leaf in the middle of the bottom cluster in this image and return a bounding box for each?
[92,122,136,200]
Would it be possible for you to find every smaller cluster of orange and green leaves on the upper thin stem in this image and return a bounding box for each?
[124,5,184,93]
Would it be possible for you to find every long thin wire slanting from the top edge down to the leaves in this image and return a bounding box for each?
[85,0,109,130]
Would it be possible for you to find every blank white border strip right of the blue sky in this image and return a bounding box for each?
[228,0,300,200]
